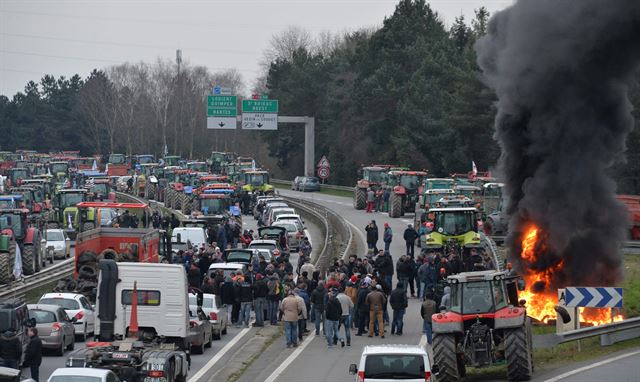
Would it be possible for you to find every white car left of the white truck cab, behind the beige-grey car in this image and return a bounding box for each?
[38,293,96,341]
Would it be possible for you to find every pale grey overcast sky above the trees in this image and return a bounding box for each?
[0,0,512,96]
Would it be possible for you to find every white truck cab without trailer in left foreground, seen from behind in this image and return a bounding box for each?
[66,260,192,382]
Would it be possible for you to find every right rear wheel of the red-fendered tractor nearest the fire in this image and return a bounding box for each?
[504,325,533,381]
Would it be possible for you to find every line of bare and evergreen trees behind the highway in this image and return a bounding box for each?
[0,0,640,193]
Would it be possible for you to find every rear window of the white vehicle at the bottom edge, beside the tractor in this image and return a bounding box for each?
[364,354,425,381]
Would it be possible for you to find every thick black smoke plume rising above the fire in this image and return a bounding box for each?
[476,0,640,287]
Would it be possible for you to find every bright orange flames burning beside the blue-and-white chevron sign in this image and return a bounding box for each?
[520,225,624,326]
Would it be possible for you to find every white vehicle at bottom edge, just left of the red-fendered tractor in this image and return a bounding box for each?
[349,345,438,382]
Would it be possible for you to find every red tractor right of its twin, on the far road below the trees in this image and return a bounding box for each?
[387,170,427,218]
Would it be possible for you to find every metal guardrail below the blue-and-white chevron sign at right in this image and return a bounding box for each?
[533,317,640,348]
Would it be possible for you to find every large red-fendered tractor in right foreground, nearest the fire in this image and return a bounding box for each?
[432,271,533,382]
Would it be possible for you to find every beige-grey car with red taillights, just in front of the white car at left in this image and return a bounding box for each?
[27,304,76,356]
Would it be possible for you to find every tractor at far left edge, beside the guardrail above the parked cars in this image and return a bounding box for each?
[0,208,44,284]
